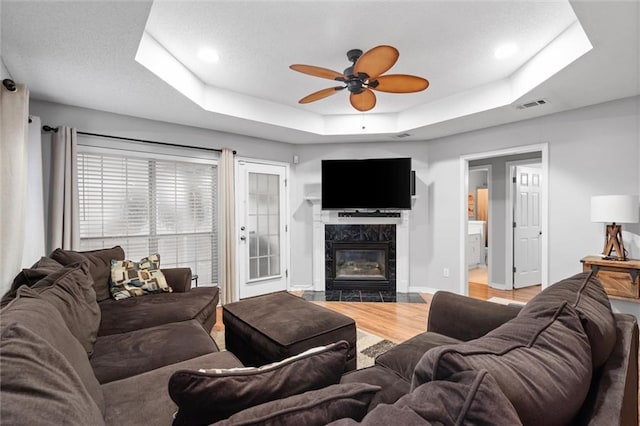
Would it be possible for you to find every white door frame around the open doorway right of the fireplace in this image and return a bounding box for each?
[458,142,549,296]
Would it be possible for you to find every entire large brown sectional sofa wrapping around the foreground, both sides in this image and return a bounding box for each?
[0,253,638,426]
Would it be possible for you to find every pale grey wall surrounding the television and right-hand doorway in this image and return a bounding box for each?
[291,97,640,292]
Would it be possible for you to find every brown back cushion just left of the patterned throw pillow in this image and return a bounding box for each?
[49,246,124,302]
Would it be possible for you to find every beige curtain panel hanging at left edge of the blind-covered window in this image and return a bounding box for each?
[47,126,80,251]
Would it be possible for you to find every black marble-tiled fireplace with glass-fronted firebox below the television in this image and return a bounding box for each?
[325,225,396,292]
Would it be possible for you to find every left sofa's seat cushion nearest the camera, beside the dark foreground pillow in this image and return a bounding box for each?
[102,351,242,425]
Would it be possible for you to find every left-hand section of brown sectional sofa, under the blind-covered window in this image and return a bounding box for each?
[0,247,228,425]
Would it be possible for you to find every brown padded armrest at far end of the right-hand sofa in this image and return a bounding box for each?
[427,291,521,341]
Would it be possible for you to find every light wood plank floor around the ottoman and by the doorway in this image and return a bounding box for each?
[213,284,540,343]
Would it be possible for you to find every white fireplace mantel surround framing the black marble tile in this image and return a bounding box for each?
[309,200,409,293]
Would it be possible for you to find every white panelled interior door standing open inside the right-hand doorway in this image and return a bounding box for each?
[513,166,542,288]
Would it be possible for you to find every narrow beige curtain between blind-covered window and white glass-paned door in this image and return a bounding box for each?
[220,148,236,305]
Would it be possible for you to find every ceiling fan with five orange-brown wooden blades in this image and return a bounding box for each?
[289,45,429,111]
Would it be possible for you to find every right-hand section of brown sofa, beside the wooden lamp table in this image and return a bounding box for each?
[337,273,638,426]
